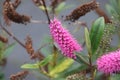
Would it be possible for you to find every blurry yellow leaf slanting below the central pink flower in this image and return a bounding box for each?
[49,58,74,77]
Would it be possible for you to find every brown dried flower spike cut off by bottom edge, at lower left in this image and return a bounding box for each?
[10,71,29,80]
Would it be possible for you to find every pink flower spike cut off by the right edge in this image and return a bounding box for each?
[97,49,120,74]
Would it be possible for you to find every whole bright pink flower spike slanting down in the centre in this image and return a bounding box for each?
[49,18,82,59]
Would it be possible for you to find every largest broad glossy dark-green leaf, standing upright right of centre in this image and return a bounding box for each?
[90,17,105,54]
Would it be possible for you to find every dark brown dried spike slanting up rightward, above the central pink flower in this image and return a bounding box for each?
[65,0,99,22]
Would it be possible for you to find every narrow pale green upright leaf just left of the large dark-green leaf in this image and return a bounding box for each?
[85,27,92,54]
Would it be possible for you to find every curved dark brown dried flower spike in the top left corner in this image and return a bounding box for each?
[3,0,30,25]
